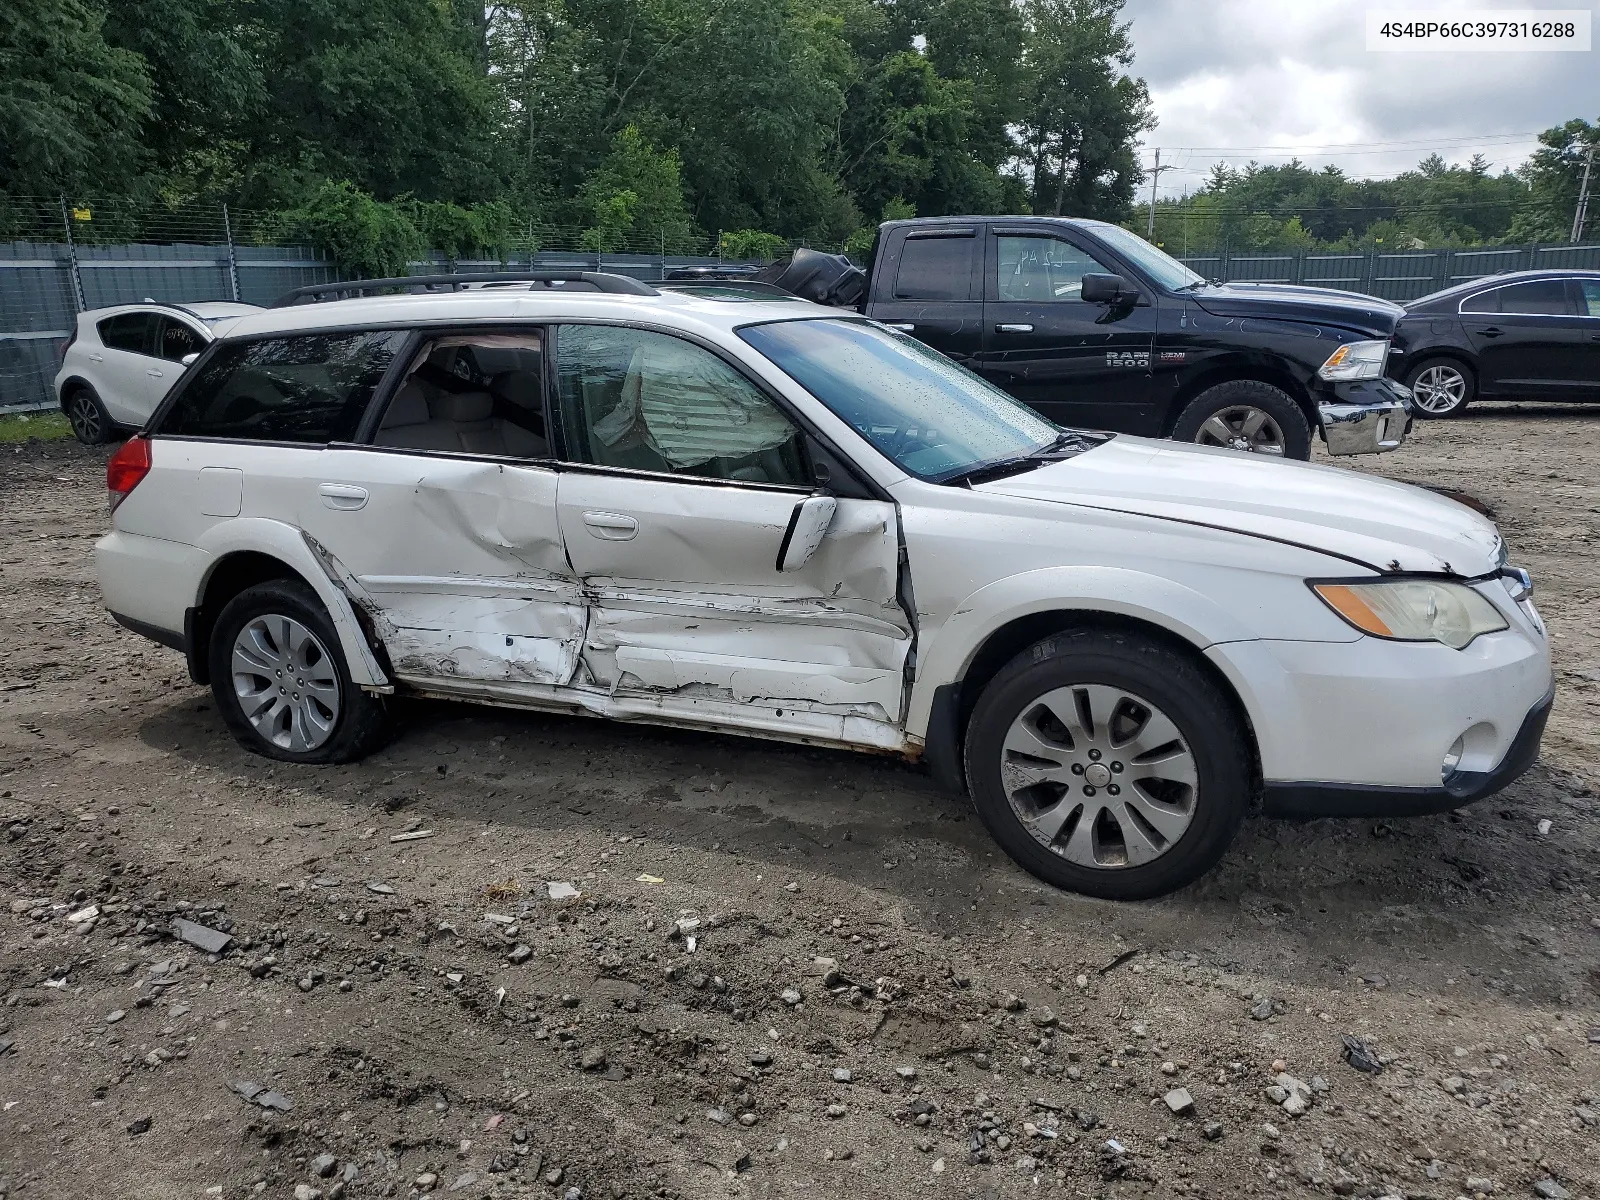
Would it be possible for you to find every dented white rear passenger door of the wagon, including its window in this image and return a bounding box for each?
[301,330,586,694]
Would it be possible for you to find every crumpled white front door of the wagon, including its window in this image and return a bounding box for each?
[555,325,910,747]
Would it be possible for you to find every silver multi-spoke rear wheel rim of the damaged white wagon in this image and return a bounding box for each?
[234,614,339,752]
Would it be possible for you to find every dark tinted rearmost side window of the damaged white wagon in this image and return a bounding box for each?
[155,330,406,445]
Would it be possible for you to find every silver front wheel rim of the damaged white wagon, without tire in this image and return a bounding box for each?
[1000,683,1198,870]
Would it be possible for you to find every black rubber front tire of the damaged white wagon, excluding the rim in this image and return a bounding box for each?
[965,630,1253,899]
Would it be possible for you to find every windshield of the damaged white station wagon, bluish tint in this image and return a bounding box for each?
[739,318,1061,483]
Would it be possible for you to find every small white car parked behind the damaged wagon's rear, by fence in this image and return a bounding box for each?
[56,301,261,446]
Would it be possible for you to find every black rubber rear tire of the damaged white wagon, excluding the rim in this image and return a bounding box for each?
[208,579,389,763]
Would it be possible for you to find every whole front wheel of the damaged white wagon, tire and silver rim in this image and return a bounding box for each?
[966,630,1251,899]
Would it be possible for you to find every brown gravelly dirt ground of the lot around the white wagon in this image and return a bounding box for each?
[0,408,1600,1200]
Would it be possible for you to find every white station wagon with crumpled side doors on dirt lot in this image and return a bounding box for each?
[96,274,1554,898]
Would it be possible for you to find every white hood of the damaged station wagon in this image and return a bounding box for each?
[973,435,1501,578]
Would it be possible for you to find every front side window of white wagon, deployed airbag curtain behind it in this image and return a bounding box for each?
[555,325,811,486]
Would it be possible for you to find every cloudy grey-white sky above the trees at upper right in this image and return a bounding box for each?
[1126,0,1600,195]
